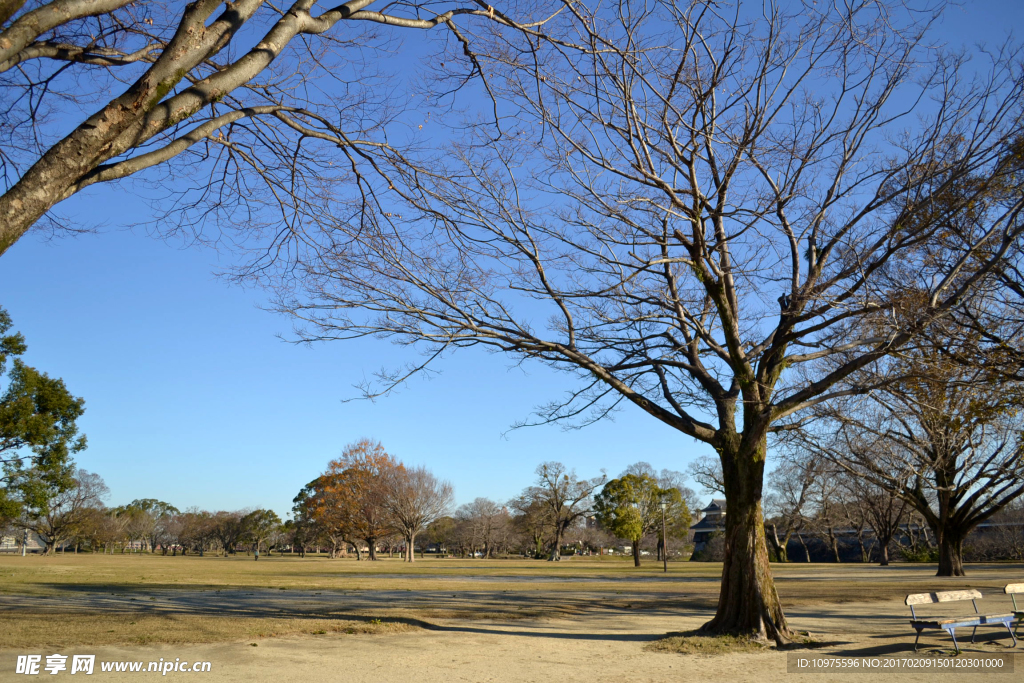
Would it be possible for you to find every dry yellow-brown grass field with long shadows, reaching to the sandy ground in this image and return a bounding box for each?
[0,554,1024,649]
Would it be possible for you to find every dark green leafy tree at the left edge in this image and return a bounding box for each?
[0,308,86,518]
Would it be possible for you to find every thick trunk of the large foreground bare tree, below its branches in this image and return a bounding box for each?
[700,436,791,644]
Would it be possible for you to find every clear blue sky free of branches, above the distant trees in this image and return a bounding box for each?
[0,0,1024,516]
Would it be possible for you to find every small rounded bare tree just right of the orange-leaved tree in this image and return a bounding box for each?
[381,467,455,562]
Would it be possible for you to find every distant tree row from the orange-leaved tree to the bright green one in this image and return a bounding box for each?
[286,439,694,566]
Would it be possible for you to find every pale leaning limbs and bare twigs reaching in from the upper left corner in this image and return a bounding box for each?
[0,0,558,254]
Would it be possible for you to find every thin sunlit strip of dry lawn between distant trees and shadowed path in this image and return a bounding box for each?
[0,553,1022,602]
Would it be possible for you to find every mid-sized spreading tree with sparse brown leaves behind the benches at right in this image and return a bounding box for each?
[792,343,1024,577]
